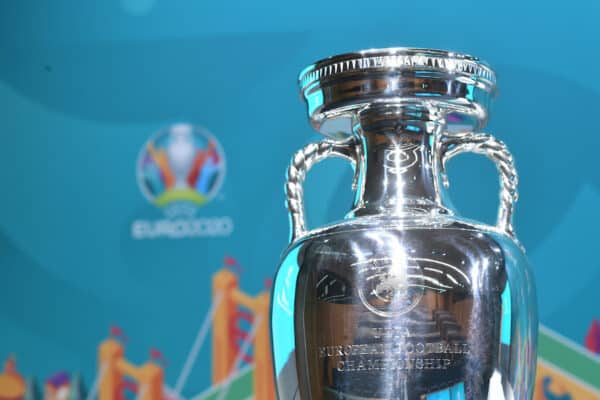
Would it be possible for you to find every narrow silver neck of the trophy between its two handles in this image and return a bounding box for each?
[351,104,450,216]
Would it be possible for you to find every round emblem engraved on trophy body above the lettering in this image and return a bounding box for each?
[356,258,425,318]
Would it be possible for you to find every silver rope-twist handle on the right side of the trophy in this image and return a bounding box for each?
[441,132,518,240]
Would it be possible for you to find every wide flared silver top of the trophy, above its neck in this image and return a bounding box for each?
[298,47,496,137]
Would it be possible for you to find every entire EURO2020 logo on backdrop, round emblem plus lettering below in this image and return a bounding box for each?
[132,123,233,239]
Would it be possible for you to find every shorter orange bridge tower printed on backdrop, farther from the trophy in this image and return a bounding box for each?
[98,338,164,400]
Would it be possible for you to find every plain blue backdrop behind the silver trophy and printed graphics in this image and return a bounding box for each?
[0,0,600,395]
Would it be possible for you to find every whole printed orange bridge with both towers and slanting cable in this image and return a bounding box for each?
[88,262,275,400]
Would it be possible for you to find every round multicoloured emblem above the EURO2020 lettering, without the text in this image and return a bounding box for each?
[137,123,225,207]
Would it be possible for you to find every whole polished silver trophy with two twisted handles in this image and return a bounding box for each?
[272,48,537,400]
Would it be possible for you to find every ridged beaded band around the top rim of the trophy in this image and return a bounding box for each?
[298,47,496,92]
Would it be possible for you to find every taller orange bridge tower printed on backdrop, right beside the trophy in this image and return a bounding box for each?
[212,269,275,400]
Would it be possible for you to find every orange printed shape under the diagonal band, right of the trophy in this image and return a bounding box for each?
[533,360,600,400]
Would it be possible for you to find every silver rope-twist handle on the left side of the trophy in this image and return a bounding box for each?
[285,138,360,242]
